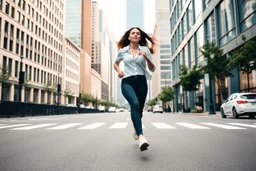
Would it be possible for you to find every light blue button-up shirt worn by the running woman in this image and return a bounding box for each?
[115,45,155,80]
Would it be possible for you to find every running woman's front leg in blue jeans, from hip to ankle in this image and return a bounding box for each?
[121,80,143,135]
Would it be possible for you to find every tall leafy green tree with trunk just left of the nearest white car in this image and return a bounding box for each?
[200,42,233,100]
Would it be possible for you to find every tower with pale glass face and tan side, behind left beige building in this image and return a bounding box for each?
[65,0,97,94]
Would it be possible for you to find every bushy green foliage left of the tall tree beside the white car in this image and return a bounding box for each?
[179,65,204,91]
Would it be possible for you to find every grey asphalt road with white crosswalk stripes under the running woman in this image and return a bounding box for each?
[0,113,256,171]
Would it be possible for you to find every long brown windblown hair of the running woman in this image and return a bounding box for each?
[117,27,156,54]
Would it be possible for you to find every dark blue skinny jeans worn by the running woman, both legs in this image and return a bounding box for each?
[121,75,148,135]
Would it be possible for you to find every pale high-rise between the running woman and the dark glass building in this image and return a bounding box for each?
[152,0,171,98]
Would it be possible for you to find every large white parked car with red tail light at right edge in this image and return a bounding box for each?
[220,93,256,119]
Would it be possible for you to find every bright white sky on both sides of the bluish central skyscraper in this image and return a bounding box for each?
[98,0,156,40]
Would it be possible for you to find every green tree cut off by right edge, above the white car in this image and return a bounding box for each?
[231,35,256,92]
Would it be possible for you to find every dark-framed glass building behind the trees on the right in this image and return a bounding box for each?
[170,0,256,112]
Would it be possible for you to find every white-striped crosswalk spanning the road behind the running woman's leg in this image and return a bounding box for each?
[0,122,256,131]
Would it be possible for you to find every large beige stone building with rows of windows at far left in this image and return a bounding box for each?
[0,0,65,104]
